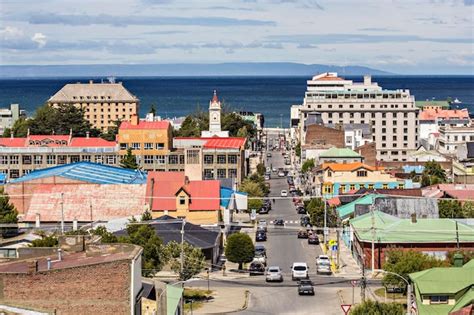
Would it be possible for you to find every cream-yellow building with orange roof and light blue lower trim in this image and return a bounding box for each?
[315,162,412,199]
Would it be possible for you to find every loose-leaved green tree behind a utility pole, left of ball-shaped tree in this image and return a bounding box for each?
[166,241,205,281]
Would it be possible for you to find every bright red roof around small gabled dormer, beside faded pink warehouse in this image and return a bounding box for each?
[146,172,220,211]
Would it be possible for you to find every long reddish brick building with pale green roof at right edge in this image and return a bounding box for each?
[349,211,474,269]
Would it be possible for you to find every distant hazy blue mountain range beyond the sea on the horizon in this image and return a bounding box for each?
[0,62,391,78]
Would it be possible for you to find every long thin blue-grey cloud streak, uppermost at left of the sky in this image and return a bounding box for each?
[29,13,276,27]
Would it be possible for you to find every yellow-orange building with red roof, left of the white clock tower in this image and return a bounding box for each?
[117,115,175,170]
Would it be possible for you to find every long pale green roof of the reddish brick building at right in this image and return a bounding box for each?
[350,211,474,243]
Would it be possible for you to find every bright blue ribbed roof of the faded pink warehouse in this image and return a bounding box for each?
[10,162,146,184]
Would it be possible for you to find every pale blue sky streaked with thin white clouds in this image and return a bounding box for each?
[0,0,474,75]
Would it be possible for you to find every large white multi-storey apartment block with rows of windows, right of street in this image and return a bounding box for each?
[292,72,418,161]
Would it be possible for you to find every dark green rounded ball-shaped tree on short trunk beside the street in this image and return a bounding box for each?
[225,233,255,270]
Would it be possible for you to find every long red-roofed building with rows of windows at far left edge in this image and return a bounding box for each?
[0,134,119,180]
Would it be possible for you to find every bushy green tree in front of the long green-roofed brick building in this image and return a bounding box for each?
[382,248,447,288]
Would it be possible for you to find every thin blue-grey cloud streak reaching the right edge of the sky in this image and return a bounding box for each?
[267,34,472,45]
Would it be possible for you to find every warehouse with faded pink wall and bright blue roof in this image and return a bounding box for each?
[5,162,146,227]
